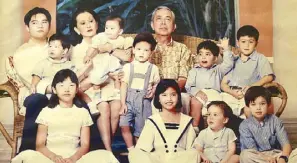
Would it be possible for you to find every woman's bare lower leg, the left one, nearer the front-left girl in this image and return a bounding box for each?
[97,102,111,151]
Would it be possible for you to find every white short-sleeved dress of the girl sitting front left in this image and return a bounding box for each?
[12,105,118,163]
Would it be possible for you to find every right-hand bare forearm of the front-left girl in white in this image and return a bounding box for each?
[65,126,90,162]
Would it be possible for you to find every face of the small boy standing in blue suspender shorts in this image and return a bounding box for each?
[133,41,152,63]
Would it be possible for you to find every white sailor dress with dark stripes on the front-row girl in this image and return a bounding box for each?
[129,113,200,163]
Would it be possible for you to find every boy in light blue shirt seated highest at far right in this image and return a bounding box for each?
[221,25,275,116]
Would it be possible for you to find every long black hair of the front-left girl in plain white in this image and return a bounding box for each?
[48,69,84,108]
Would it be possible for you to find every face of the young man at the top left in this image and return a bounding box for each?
[26,13,50,40]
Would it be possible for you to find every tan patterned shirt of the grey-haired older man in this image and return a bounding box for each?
[151,39,192,80]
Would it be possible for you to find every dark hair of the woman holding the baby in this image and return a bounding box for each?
[70,7,100,46]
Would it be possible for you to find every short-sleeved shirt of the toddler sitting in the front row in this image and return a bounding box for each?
[194,127,237,162]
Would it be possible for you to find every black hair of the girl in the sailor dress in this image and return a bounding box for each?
[154,79,182,112]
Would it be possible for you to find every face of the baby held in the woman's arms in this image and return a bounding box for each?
[104,20,123,40]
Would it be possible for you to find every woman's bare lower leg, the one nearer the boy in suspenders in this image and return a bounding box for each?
[109,100,121,136]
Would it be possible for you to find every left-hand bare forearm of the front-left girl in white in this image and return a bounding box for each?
[36,124,63,163]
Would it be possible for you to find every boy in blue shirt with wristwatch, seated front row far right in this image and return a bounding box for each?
[239,86,291,163]
